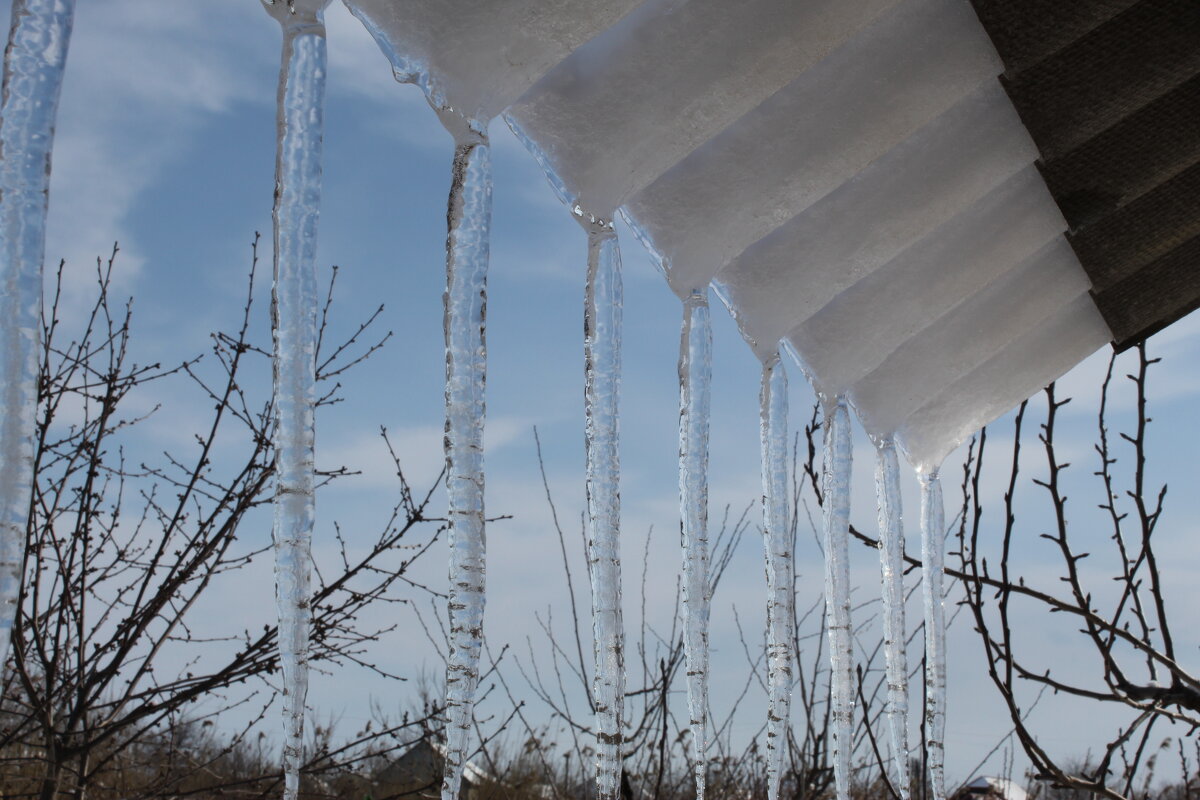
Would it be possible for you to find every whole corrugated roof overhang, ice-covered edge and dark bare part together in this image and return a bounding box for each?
[347,0,1200,467]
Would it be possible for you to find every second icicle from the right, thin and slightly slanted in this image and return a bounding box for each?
[875,439,910,800]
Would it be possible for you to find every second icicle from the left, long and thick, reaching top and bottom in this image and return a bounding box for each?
[266,0,328,800]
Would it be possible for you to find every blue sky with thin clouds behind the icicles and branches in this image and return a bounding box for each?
[14,0,1200,778]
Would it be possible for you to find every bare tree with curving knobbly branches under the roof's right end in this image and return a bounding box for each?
[959,344,1200,800]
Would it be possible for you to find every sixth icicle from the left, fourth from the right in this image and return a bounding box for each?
[758,353,796,800]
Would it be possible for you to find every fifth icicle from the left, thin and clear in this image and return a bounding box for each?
[679,289,713,800]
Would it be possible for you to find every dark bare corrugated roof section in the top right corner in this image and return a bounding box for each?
[973,0,1200,348]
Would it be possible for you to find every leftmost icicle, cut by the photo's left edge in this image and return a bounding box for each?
[0,0,74,669]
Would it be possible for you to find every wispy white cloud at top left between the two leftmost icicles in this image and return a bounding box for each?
[37,0,278,299]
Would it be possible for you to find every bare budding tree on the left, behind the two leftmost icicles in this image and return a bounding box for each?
[0,236,443,800]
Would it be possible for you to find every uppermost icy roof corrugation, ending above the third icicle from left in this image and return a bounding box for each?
[346,0,638,122]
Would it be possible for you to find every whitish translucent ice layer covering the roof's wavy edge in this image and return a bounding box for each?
[348,0,1112,467]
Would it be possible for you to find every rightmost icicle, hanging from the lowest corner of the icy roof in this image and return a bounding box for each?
[918,469,946,800]
